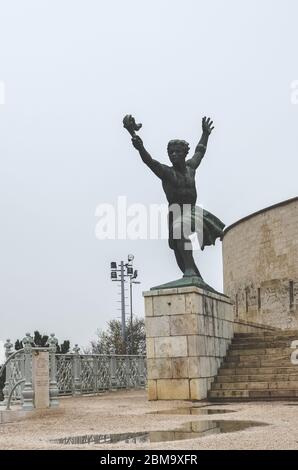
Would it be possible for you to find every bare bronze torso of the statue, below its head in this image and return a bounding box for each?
[162,166,197,205]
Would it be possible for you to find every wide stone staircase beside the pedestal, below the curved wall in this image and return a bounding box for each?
[208,330,298,401]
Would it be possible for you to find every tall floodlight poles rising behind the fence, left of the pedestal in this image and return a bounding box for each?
[111,255,139,344]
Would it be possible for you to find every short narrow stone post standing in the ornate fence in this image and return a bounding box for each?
[32,351,50,409]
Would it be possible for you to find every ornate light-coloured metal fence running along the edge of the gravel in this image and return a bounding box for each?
[0,335,147,407]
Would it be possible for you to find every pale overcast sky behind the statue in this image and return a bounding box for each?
[0,0,298,346]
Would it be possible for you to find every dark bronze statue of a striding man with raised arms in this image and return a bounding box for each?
[123,115,224,288]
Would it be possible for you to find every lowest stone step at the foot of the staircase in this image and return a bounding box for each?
[208,390,298,401]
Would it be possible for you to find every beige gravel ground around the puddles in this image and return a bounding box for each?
[0,390,298,450]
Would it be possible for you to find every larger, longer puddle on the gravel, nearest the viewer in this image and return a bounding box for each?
[52,420,268,445]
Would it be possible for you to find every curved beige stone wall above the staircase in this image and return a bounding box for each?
[223,198,298,329]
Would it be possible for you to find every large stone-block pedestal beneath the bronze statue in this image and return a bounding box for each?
[144,287,234,400]
